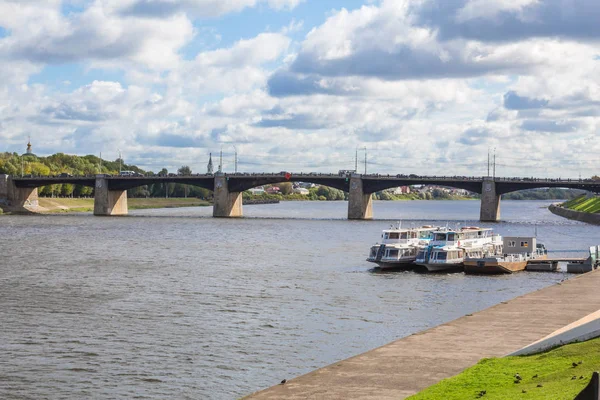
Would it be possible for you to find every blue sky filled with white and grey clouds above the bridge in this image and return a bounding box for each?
[0,0,600,178]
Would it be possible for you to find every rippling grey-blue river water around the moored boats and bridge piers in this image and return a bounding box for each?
[0,201,600,399]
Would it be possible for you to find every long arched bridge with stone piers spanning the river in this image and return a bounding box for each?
[0,172,600,222]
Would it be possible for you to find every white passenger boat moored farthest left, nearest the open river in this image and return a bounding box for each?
[367,224,440,270]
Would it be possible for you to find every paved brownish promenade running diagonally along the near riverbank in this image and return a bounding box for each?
[245,270,600,400]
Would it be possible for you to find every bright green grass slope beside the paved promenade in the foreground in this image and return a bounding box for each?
[408,338,600,400]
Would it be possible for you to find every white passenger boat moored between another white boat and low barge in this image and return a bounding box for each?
[415,226,502,272]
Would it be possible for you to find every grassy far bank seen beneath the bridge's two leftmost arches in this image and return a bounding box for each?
[39,197,210,213]
